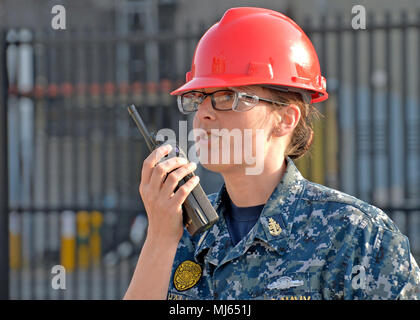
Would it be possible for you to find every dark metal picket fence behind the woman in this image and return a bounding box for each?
[0,13,420,299]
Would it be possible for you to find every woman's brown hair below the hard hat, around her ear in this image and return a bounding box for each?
[267,89,322,160]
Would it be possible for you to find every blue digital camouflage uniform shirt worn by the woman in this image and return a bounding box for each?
[168,158,420,300]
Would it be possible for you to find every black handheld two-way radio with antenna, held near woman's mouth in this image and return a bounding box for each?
[128,105,219,236]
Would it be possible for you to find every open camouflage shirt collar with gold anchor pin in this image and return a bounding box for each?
[194,157,306,264]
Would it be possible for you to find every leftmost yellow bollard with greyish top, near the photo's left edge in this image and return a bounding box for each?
[9,211,22,270]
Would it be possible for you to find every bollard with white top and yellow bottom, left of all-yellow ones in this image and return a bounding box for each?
[60,211,76,272]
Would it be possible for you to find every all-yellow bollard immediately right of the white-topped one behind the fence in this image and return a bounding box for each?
[77,211,90,269]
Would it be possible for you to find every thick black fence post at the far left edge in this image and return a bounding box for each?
[0,30,9,300]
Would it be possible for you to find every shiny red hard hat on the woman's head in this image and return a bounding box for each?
[171,7,328,103]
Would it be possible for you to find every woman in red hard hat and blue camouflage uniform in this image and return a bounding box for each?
[125,8,420,300]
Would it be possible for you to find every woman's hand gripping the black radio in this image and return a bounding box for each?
[139,145,200,245]
